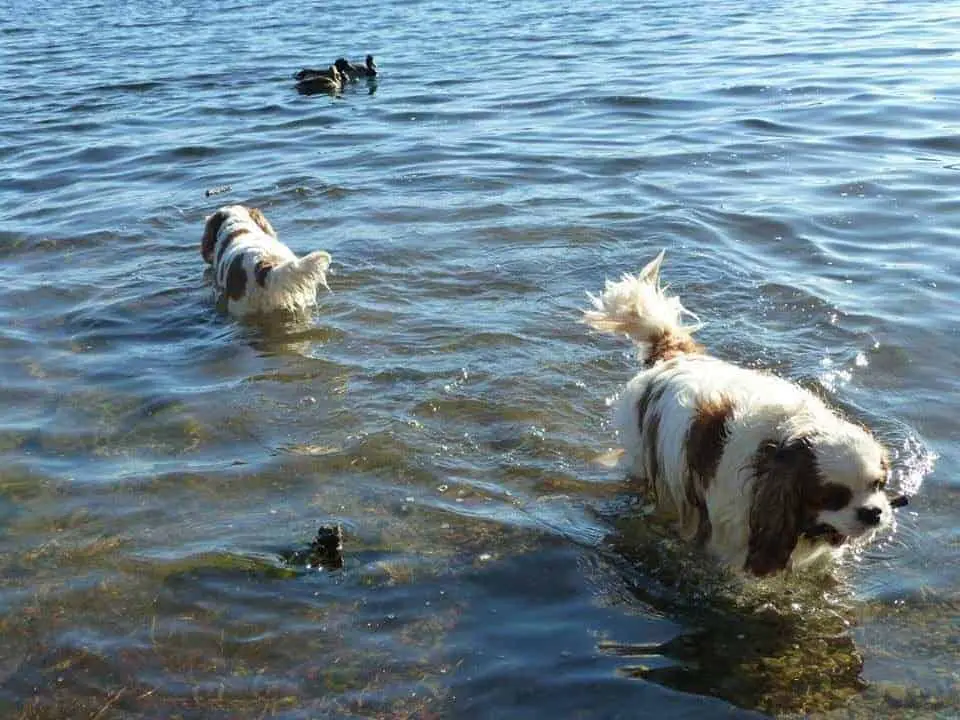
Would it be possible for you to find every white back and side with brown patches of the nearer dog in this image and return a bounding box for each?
[613,353,836,565]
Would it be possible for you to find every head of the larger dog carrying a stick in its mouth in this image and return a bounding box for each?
[746,424,893,575]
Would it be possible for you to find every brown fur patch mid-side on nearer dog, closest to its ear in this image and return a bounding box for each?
[684,398,733,545]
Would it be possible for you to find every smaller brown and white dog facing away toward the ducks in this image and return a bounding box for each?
[200,205,331,316]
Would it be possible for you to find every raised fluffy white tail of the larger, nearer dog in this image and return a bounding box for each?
[583,250,703,366]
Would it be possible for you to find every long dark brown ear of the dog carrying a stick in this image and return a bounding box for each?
[744,438,819,575]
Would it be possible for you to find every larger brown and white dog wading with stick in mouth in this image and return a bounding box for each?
[584,252,893,575]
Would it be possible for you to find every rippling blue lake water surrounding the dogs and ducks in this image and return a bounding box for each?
[0,0,960,719]
